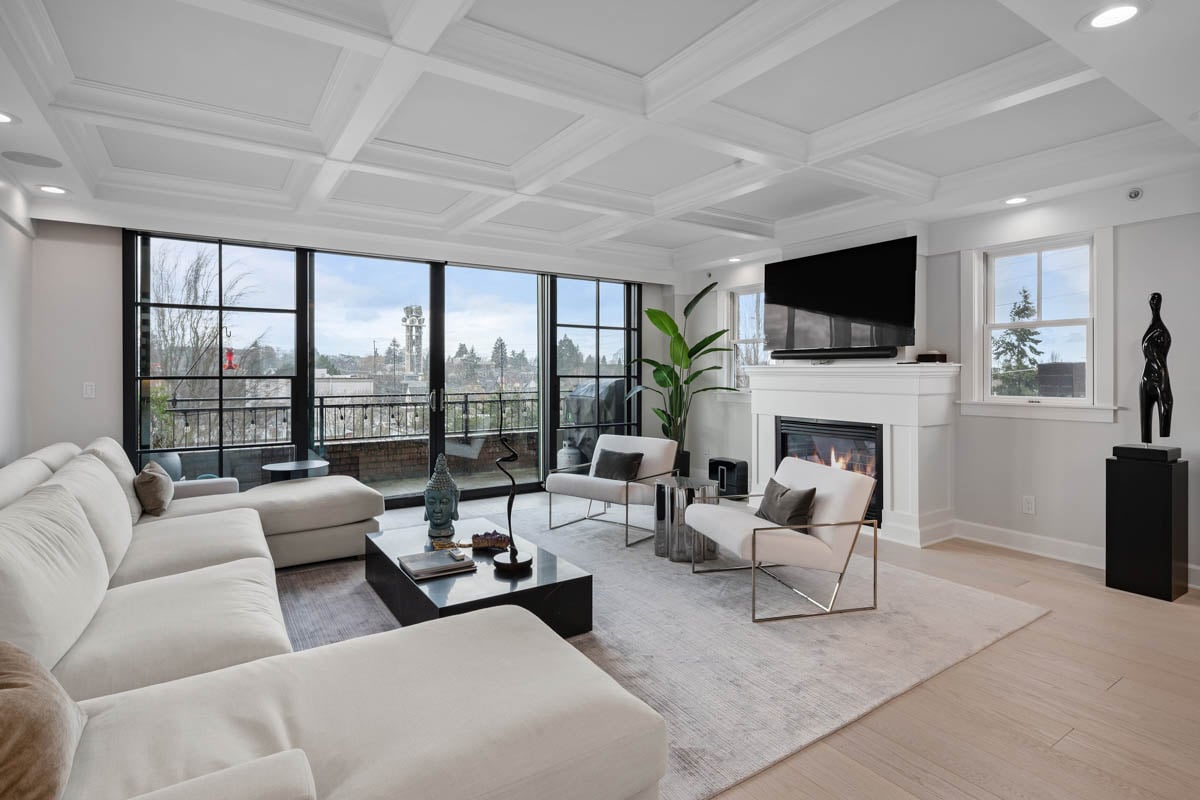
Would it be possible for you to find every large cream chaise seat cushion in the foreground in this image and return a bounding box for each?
[66,606,666,800]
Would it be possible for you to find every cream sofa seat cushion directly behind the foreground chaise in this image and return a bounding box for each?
[53,558,292,699]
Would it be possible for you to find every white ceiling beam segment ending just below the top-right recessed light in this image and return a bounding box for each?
[809,42,1100,163]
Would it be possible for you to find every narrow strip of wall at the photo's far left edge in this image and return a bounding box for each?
[0,217,34,464]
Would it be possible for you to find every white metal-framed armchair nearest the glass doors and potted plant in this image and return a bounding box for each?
[544,433,676,547]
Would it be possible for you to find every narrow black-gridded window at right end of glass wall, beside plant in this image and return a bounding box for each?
[547,277,641,467]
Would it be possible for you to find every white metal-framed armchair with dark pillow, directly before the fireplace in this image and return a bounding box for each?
[684,458,880,622]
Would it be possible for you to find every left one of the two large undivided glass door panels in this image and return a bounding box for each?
[311,252,444,499]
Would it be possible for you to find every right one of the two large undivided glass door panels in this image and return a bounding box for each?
[442,265,541,495]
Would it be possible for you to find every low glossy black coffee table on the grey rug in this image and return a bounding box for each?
[366,519,592,637]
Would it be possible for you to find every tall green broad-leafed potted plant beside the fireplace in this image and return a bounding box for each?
[625,282,737,475]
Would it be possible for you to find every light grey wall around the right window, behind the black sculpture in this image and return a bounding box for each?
[926,213,1200,564]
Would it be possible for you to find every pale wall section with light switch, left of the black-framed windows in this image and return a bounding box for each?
[26,222,122,449]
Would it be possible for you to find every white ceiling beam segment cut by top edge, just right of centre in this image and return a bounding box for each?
[646,0,899,121]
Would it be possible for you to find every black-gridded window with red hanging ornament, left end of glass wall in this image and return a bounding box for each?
[126,233,307,487]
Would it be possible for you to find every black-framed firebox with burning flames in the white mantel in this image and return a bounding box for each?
[775,416,883,523]
